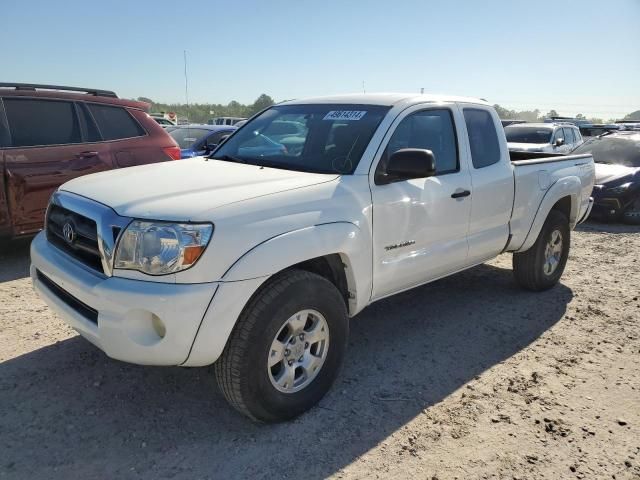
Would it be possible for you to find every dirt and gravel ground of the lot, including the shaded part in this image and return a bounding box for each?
[0,224,640,479]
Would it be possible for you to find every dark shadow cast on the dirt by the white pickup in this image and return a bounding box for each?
[0,265,573,479]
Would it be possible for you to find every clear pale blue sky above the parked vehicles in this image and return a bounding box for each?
[0,0,640,119]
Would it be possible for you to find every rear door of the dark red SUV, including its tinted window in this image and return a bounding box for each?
[2,96,113,235]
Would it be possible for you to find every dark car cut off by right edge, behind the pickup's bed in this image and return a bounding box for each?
[572,131,640,225]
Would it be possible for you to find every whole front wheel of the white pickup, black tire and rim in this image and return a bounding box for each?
[214,270,349,422]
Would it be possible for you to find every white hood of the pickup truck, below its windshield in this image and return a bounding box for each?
[60,157,338,221]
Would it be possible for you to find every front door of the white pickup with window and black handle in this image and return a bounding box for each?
[371,105,472,300]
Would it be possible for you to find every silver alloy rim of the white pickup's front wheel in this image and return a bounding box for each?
[267,309,329,393]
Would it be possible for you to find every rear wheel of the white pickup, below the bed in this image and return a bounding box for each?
[513,210,571,292]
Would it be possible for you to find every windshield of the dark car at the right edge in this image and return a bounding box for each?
[571,134,640,167]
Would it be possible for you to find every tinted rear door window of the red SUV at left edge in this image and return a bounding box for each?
[4,98,82,147]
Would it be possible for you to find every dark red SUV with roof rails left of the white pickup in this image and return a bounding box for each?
[0,83,180,237]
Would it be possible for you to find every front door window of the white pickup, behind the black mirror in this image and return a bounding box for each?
[381,110,458,175]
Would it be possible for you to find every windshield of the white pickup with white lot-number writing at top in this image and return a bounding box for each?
[212,104,389,174]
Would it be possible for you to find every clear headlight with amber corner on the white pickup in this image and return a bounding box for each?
[114,220,213,275]
